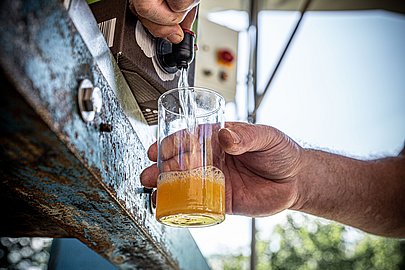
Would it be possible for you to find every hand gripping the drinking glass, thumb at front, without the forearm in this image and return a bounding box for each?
[141,122,303,216]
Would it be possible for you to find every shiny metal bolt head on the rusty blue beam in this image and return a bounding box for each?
[78,79,103,122]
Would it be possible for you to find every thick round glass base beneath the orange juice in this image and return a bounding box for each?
[158,213,225,228]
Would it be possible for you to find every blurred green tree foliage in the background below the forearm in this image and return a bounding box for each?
[210,215,405,270]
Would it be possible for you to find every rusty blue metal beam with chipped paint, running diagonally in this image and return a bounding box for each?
[0,0,208,269]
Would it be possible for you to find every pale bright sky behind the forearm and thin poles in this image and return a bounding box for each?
[190,7,405,256]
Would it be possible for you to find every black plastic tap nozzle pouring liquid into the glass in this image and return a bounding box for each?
[156,29,195,74]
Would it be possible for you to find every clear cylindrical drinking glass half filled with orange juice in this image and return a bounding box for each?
[156,87,225,227]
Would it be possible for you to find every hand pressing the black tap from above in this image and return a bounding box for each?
[129,0,200,43]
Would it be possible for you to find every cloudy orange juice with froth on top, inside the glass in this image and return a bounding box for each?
[156,166,225,227]
